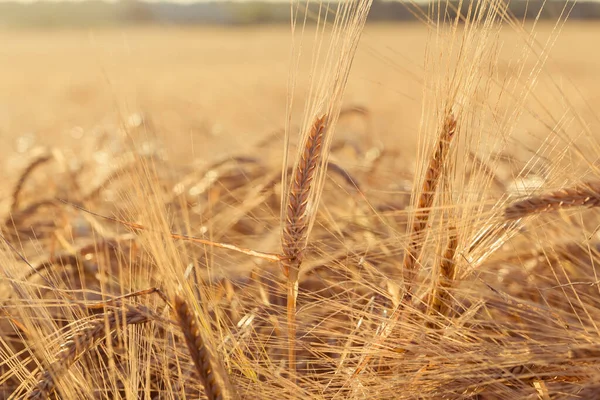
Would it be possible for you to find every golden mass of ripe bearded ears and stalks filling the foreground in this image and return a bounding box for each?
[0,0,600,399]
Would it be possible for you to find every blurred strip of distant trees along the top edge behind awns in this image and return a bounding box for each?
[0,0,600,27]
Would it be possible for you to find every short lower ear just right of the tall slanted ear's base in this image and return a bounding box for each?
[427,227,458,327]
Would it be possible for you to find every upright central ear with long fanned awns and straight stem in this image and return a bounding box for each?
[281,0,372,381]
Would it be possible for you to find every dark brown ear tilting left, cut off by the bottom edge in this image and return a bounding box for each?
[174,296,238,400]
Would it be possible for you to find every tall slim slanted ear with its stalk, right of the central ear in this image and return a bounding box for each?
[353,112,456,376]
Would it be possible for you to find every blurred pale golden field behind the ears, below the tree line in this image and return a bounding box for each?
[0,21,600,167]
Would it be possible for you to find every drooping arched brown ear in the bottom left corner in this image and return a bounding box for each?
[26,306,160,400]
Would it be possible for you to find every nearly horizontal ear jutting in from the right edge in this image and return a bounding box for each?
[504,181,600,220]
